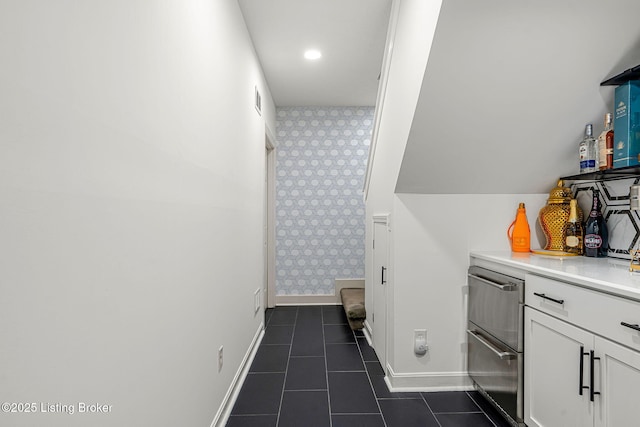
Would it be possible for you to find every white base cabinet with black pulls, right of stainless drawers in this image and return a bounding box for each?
[524,275,640,427]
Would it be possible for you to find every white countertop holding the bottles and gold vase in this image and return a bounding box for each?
[471,252,640,301]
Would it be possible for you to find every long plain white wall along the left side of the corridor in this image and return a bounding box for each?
[0,0,275,426]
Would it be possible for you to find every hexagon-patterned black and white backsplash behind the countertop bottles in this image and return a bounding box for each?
[571,178,640,259]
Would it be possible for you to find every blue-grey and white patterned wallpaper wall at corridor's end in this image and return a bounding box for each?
[276,107,374,295]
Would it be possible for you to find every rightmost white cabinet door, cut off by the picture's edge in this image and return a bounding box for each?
[594,337,640,427]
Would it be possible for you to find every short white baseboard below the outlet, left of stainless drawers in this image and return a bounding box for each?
[384,365,474,392]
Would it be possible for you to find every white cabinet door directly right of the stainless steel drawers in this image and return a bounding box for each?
[524,307,594,427]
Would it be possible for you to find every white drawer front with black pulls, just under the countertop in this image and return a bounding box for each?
[525,274,640,350]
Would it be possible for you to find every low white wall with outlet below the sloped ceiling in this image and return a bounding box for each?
[389,194,547,389]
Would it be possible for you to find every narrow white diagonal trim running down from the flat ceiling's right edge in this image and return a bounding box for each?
[363,0,400,200]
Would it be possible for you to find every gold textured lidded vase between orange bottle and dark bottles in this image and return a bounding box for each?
[538,180,584,252]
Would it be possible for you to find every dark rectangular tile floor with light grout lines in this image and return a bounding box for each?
[227,306,508,427]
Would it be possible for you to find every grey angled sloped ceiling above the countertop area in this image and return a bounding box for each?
[396,0,640,194]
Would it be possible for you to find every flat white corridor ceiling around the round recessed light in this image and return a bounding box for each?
[238,0,391,107]
